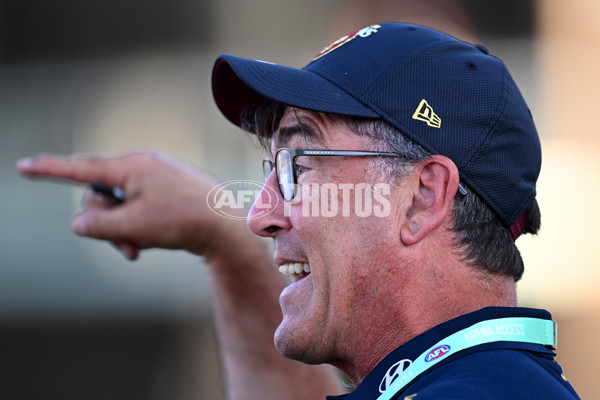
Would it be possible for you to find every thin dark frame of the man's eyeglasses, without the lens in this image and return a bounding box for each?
[262,147,410,202]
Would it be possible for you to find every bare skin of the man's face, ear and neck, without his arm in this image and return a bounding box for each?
[249,110,515,384]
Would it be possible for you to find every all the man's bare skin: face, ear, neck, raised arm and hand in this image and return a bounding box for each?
[17,106,516,399]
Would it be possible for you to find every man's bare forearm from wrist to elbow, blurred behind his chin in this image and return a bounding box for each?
[207,220,341,400]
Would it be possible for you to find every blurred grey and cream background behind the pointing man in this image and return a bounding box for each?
[0,0,600,400]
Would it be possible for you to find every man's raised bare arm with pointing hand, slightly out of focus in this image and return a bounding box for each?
[17,153,341,400]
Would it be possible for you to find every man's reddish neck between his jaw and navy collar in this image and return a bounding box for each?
[331,253,517,385]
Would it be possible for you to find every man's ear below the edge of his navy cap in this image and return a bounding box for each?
[400,154,459,246]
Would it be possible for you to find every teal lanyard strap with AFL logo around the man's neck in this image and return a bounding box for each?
[377,318,556,400]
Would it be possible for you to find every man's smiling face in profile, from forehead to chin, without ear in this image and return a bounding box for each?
[248,109,402,364]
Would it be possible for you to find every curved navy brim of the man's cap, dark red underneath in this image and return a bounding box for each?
[212,54,379,126]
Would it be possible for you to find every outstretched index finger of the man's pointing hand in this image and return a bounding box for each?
[16,155,128,186]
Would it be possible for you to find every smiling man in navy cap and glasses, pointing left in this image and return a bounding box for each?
[19,24,578,399]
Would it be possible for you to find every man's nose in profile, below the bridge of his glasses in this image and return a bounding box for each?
[248,171,291,238]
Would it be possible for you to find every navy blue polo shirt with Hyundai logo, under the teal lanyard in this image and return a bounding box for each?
[327,307,579,400]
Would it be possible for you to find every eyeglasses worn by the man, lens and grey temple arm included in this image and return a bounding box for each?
[263,147,402,202]
